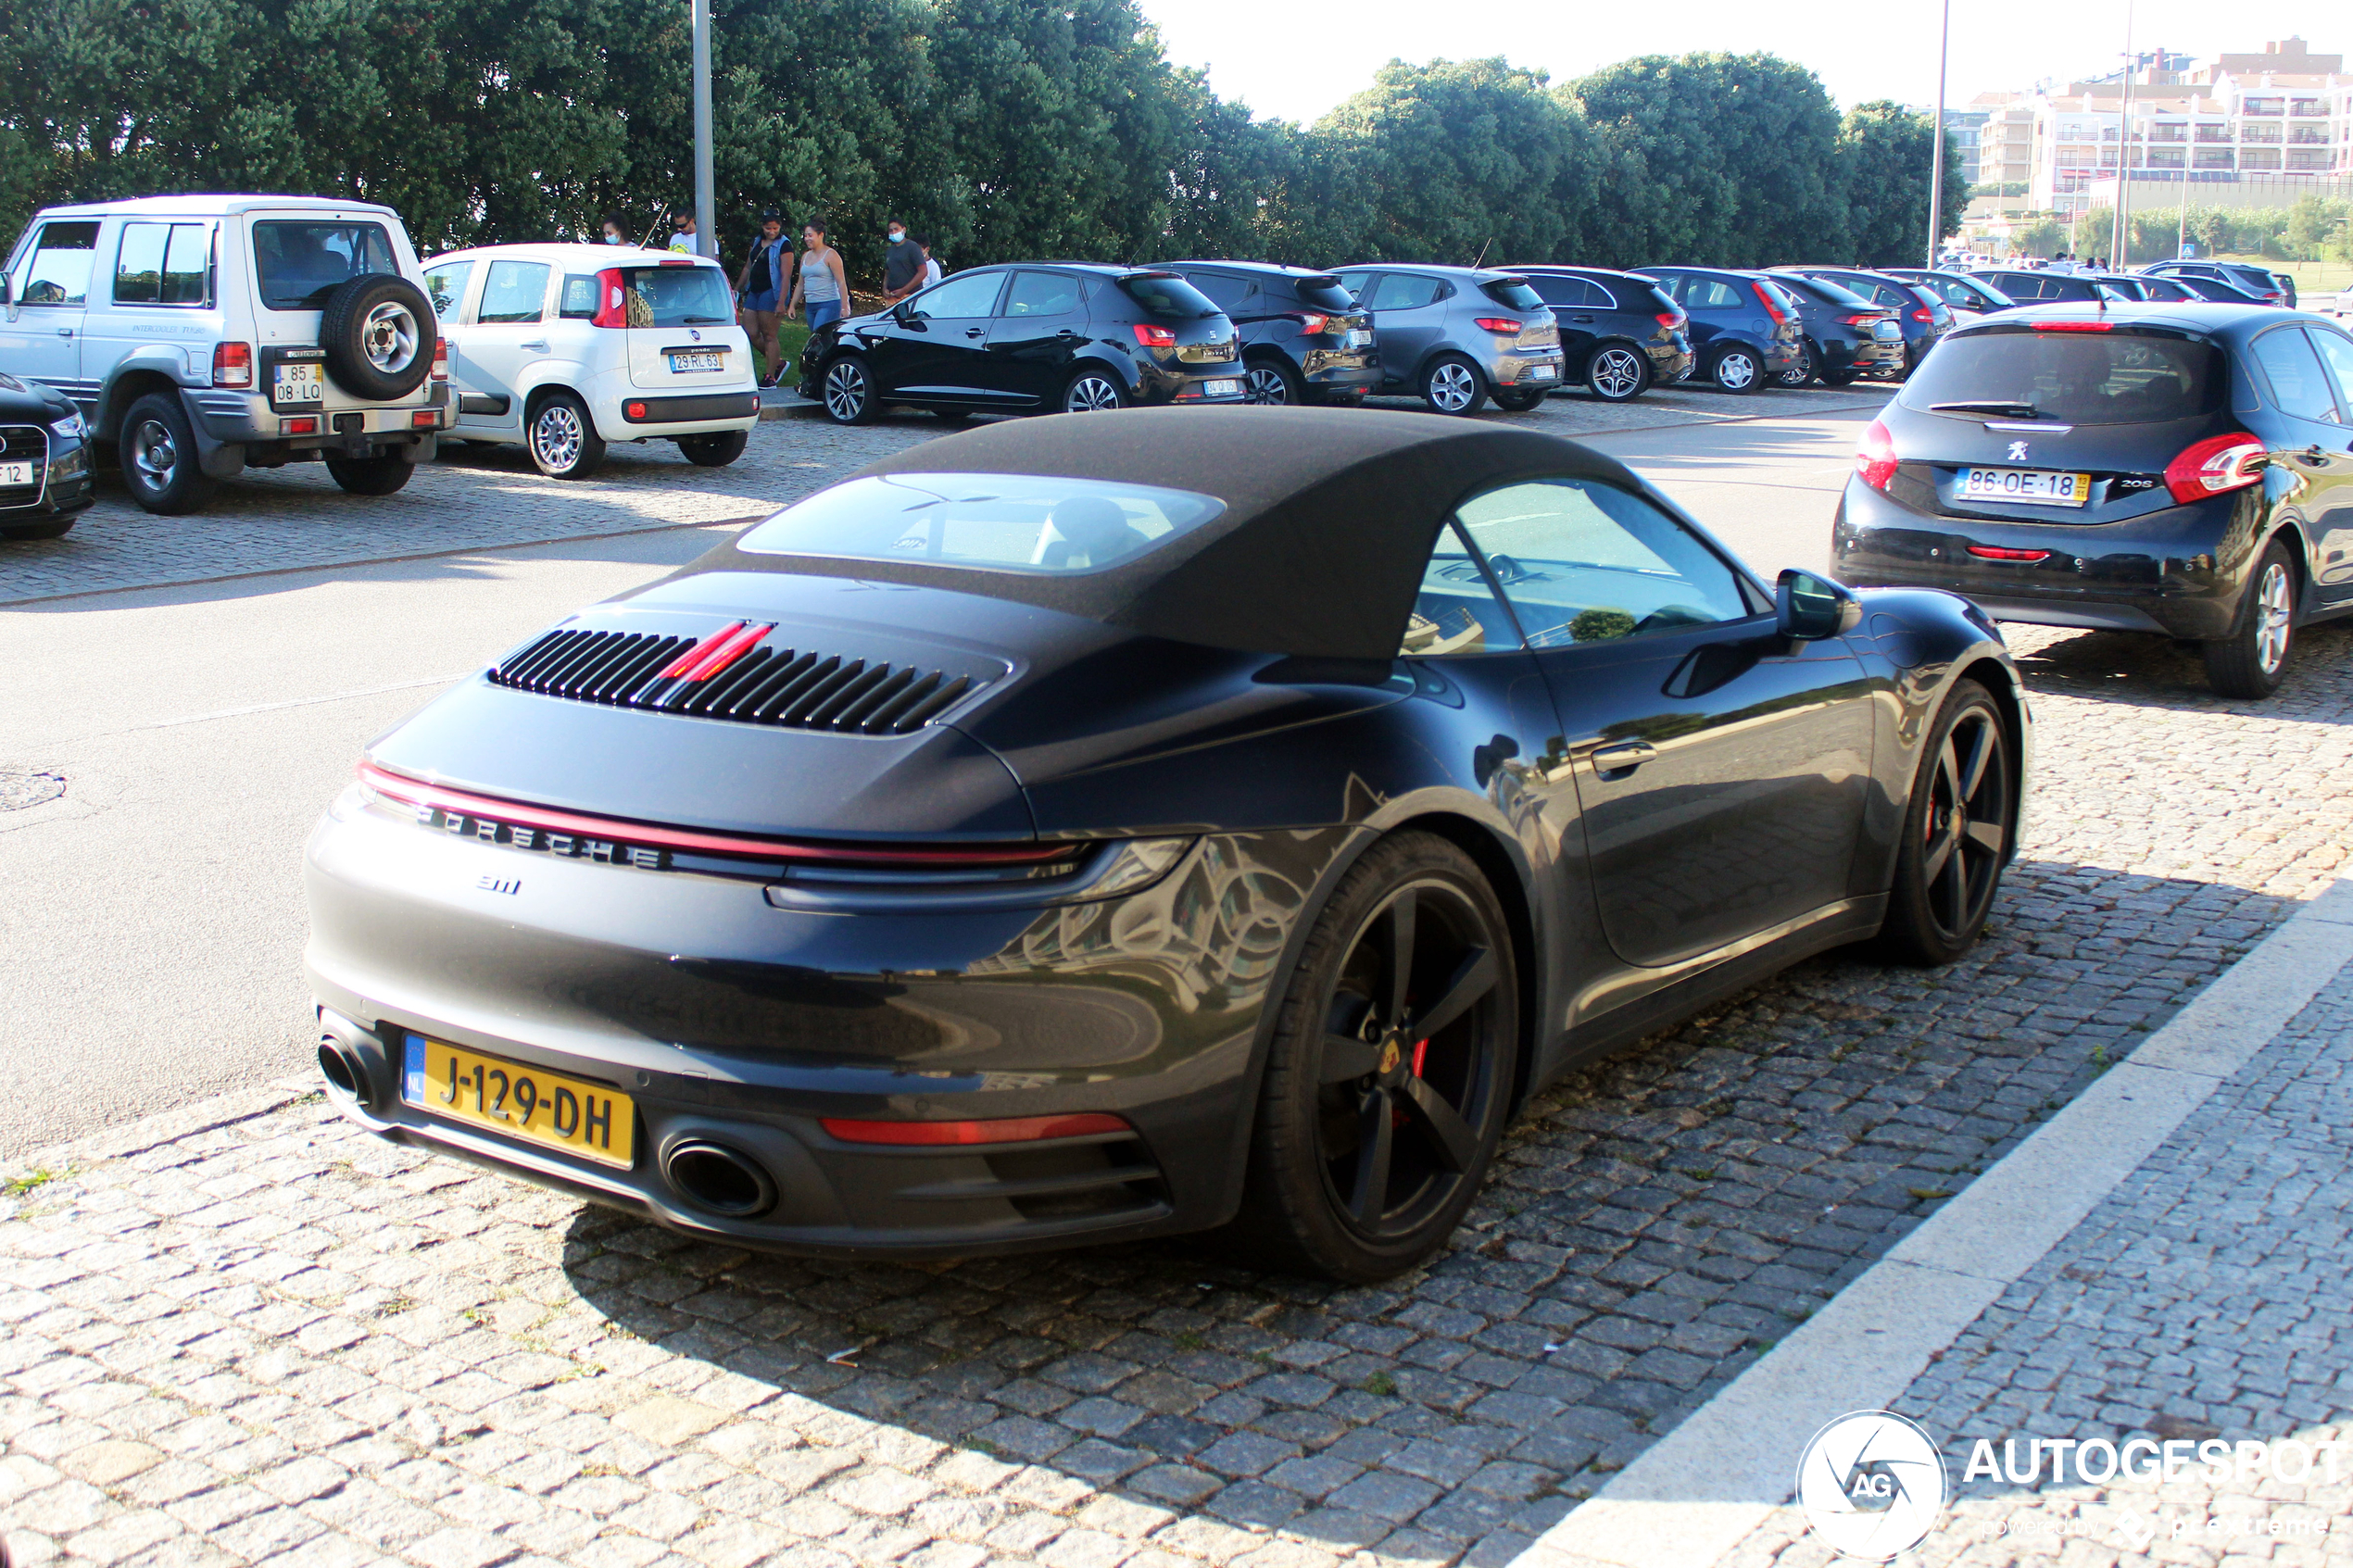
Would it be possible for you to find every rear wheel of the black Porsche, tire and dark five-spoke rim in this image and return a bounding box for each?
[1230,833,1520,1284]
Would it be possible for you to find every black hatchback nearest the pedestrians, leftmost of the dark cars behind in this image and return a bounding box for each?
[800,261,1242,425]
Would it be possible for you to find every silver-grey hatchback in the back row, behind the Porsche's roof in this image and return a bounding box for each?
[1334,261,1560,414]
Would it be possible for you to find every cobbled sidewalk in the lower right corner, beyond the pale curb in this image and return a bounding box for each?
[1725,969,2353,1568]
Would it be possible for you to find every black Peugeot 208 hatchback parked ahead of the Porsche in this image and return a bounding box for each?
[1833,303,2353,696]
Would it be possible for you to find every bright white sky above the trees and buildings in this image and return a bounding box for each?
[1141,0,2353,119]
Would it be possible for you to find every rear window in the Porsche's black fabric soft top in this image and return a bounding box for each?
[736,472,1226,573]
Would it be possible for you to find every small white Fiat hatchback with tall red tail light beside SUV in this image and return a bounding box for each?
[426,245,760,480]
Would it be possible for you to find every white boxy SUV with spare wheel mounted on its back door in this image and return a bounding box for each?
[0,195,449,512]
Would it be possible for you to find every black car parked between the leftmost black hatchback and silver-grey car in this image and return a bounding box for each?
[1160,261,1381,405]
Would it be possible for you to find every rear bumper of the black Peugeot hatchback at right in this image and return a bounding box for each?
[1831,480,2259,642]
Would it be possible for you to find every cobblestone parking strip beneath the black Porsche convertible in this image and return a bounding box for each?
[13,610,2353,1568]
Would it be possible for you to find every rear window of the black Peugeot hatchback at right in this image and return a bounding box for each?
[1899,327,2231,425]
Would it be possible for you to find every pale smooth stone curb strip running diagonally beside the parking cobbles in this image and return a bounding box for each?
[1513,879,2353,1568]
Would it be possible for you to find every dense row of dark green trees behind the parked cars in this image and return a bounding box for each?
[0,0,1962,285]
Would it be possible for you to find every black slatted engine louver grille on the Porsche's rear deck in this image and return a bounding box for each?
[489,633,988,735]
